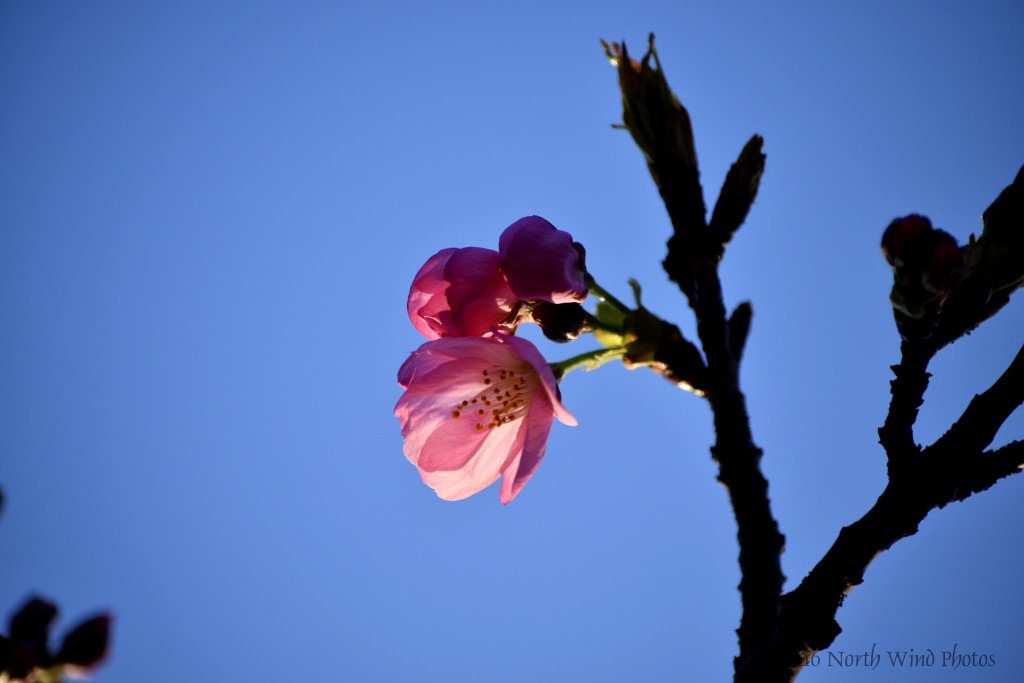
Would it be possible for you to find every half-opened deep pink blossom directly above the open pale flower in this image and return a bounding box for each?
[408,247,519,339]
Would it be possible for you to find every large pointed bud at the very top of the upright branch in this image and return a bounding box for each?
[601,34,697,181]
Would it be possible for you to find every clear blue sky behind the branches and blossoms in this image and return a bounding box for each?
[0,0,1024,683]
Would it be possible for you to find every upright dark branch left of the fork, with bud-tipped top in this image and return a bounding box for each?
[605,36,785,668]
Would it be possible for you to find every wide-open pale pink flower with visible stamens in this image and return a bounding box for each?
[394,334,577,504]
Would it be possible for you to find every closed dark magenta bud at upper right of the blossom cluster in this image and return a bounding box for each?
[498,216,587,303]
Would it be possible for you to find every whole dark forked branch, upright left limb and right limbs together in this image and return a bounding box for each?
[605,36,1024,683]
